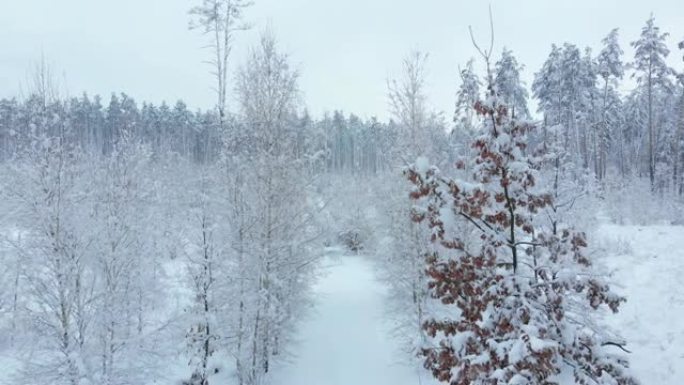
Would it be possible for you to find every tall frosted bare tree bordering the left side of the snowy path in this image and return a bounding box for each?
[225,32,316,384]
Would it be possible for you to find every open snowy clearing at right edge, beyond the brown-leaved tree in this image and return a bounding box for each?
[598,225,684,385]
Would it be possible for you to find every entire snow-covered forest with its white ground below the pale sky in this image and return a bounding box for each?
[0,0,684,385]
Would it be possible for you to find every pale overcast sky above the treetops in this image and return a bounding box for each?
[0,0,684,119]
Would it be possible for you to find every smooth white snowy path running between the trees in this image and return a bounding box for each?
[271,252,427,385]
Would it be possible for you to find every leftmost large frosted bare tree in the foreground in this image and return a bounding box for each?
[6,107,95,385]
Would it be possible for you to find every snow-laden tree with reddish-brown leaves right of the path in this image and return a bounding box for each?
[406,89,637,385]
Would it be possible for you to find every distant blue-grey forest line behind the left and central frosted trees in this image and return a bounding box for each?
[0,93,454,174]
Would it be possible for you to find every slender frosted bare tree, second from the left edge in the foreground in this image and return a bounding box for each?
[90,132,167,385]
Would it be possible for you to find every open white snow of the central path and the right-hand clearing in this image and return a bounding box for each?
[271,225,684,385]
